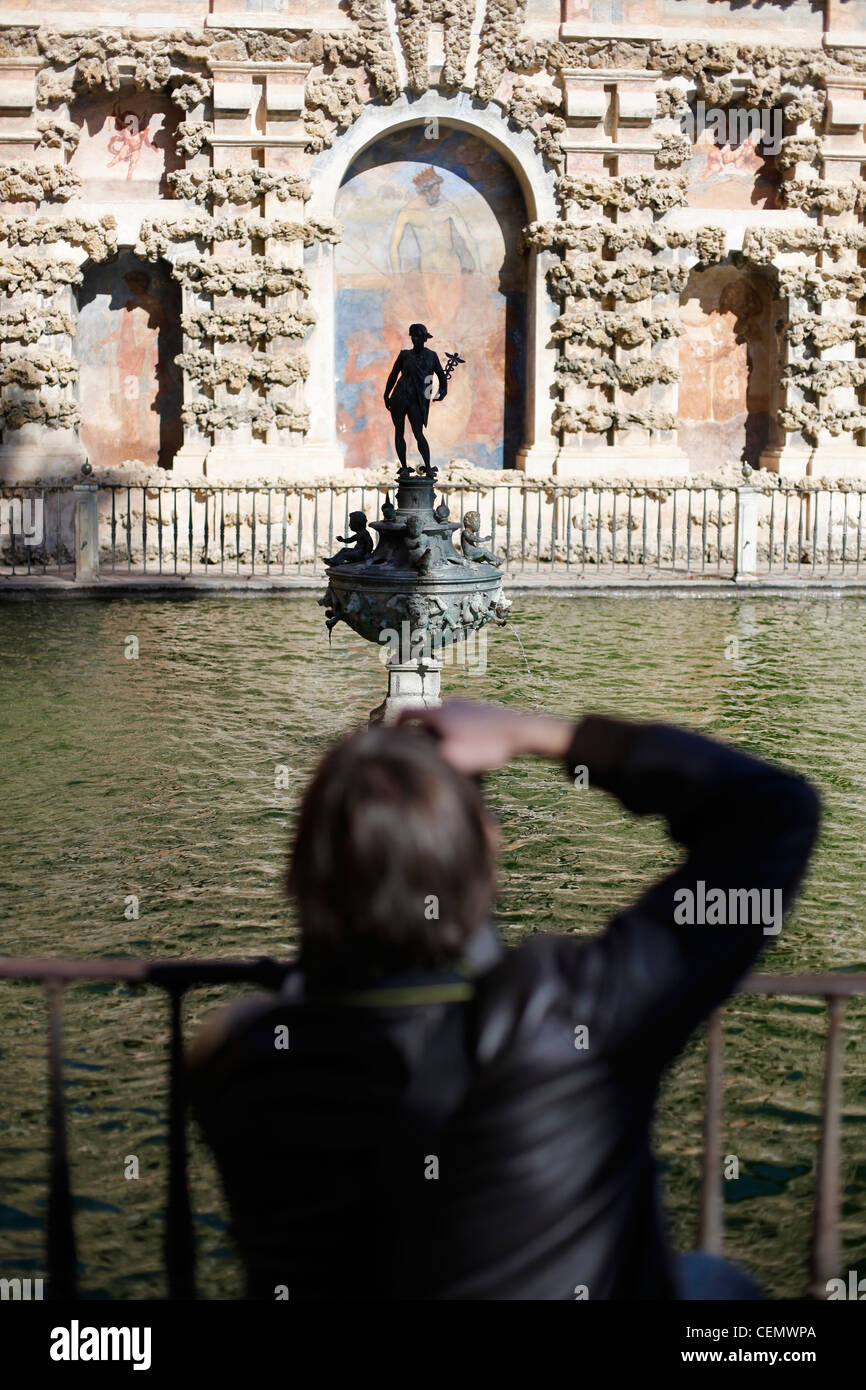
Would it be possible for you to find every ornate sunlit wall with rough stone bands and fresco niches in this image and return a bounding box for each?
[0,0,866,480]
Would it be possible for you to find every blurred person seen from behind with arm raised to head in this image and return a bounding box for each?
[189,702,819,1300]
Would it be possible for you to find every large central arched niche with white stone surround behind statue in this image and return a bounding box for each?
[304,92,557,473]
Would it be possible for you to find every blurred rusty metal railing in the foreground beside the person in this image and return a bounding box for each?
[0,958,866,1298]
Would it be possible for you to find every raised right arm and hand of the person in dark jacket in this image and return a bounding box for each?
[400,703,819,1065]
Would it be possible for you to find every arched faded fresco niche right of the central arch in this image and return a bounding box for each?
[678,265,781,473]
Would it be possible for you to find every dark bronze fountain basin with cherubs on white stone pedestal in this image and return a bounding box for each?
[318,473,510,721]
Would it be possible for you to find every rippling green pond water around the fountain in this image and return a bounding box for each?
[0,596,866,1298]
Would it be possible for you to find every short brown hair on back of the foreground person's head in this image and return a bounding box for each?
[286,726,495,979]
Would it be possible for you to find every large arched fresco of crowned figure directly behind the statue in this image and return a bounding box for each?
[336,126,527,468]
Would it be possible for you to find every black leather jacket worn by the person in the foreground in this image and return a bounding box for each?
[192,719,819,1301]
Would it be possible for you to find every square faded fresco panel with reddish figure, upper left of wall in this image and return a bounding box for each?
[70,92,183,202]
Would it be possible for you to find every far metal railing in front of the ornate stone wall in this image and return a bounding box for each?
[0,480,866,581]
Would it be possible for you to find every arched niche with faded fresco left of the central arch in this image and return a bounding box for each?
[72,250,183,468]
